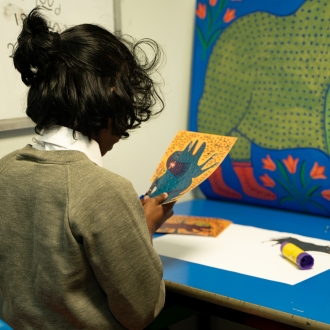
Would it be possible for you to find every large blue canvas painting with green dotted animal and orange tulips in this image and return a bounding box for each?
[189,0,330,216]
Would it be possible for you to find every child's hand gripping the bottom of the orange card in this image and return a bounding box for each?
[141,193,175,241]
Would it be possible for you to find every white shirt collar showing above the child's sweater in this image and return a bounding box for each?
[33,126,103,167]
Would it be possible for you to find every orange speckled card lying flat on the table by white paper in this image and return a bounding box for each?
[156,215,231,237]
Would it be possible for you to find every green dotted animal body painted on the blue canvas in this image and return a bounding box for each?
[198,0,330,161]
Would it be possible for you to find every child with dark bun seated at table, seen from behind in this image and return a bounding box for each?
[0,9,173,330]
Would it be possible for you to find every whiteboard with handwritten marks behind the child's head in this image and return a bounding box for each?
[0,0,120,131]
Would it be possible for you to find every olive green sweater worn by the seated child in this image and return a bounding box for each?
[0,145,165,330]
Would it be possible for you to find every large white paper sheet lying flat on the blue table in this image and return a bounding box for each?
[153,224,330,285]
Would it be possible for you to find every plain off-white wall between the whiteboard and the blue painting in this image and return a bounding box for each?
[0,0,199,200]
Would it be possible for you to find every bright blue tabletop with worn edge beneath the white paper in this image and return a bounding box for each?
[154,200,330,330]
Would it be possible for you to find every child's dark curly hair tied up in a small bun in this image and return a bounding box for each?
[13,9,163,138]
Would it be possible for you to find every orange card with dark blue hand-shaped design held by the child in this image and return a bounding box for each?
[149,131,237,203]
